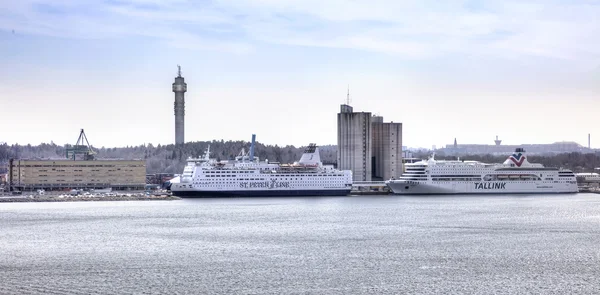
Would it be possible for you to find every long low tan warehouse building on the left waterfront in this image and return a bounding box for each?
[8,159,146,191]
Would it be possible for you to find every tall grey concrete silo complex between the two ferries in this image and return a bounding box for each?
[337,100,403,181]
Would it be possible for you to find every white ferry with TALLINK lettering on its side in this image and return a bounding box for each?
[386,148,578,195]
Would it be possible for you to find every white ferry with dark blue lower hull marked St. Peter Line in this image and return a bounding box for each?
[170,136,352,197]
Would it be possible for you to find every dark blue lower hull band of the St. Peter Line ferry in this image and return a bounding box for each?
[173,190,350,198]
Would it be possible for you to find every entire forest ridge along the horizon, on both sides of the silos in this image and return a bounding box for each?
[0,140,600,174]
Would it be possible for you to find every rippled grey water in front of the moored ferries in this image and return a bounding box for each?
[0,194,600,294]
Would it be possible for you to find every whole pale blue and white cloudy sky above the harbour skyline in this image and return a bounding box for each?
[0,0,600,148]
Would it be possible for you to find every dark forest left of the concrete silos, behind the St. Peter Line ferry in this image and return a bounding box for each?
[0,140,336,174]
